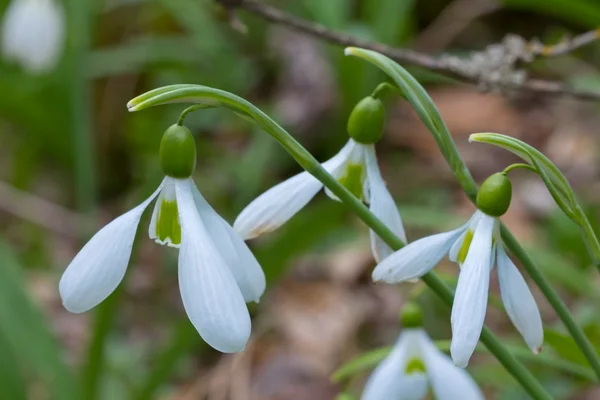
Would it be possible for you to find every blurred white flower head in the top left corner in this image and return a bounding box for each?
[2,0,65,74]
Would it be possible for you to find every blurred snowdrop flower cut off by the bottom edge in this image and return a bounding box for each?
[361,305,484,400]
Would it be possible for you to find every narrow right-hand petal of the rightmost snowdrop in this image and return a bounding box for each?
[496,245,544,354]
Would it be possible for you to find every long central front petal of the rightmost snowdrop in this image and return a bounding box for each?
[450,216,496,368]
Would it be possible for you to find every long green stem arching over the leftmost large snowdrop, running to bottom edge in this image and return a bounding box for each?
[128,85,552,400]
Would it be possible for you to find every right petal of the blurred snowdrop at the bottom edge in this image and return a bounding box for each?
[421,332,485,400]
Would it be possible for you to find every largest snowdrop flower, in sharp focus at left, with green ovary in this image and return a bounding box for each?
[59,125,265,353]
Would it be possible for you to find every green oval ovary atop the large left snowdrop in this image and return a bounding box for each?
[159,124,196,179]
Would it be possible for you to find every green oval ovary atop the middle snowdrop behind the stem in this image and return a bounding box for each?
[348,96,385,144]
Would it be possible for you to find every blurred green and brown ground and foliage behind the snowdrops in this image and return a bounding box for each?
[0,0,600,400]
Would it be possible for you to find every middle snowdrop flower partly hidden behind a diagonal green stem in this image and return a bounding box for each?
[233,96,406,261]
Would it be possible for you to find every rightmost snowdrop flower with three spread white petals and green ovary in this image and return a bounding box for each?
[373,173,544,367]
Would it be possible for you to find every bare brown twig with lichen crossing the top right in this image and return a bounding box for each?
[215,0,600,100]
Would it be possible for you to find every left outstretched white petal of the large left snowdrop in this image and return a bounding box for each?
[59,184,162,313]
